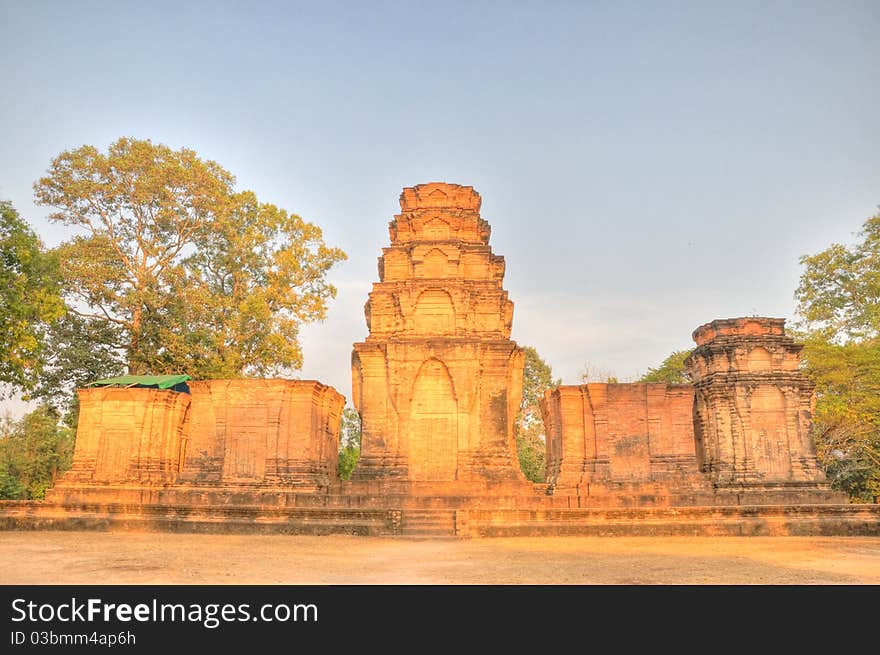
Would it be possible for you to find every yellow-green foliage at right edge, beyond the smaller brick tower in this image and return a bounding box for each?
[795,214,880,502]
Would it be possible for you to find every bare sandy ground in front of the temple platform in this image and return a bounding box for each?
[0,532,880,584]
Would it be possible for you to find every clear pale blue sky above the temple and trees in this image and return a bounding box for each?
[0,0,880,410]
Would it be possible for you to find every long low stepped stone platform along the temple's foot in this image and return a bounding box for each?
[0,497,880,538]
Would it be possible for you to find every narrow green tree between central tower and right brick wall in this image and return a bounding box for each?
[514,346,561,482]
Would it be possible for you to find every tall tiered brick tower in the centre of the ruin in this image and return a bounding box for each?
[351,182,525,483]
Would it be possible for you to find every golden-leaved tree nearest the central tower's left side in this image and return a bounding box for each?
[158,191,345,378]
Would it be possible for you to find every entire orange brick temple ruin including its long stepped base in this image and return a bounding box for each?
[0,183,880,537]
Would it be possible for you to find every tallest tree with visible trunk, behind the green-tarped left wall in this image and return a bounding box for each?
[34,138,234,373]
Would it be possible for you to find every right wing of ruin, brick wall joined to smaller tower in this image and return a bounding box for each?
[541,317,845,506]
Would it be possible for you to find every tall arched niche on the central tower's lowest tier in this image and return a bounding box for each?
[409,359,458,480]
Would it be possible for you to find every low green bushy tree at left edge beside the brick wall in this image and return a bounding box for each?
[0,405,73,500]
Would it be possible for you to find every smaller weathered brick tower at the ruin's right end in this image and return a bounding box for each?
[685,317,828,500]
